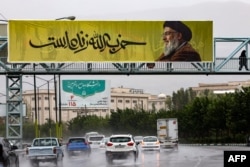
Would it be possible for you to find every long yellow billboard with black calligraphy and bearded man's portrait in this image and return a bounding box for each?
[8,20,213,63]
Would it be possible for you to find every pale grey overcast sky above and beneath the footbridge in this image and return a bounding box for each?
[0,0,250,95]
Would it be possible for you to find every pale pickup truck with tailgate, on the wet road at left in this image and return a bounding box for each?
[26,137,64,166]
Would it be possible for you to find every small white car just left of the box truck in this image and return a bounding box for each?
[140,136,160,151]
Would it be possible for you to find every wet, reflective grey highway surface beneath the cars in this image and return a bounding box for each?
[20,145,250,167]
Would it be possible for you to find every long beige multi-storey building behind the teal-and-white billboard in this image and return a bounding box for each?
[23,87,166,124]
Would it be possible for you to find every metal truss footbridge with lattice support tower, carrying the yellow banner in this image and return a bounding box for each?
[0,36,250,147]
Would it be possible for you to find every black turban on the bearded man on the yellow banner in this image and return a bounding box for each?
[163,21,192,41]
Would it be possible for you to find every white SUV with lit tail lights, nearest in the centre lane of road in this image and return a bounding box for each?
[105,134,139,164]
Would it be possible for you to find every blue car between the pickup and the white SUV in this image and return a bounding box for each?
[66,137,91,157]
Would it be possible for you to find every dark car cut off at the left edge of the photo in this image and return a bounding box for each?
[0,137,19,167]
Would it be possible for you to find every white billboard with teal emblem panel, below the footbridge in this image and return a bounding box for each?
[61,79,110,109]
